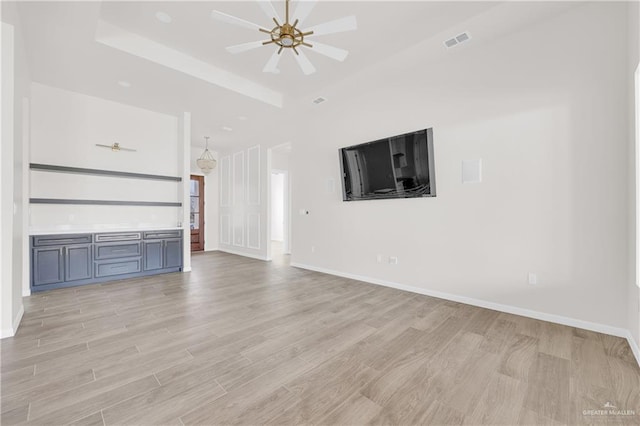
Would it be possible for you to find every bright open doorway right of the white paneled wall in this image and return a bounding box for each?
[269,143,291,263]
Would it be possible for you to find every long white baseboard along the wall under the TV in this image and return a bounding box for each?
[291,262,640,340]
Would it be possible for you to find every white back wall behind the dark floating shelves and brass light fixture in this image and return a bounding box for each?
[30,83,182,233]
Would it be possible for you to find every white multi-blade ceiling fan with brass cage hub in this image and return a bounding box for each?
[211,0,358,75]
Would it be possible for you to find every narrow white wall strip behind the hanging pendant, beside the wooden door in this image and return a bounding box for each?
[191,146,220,251]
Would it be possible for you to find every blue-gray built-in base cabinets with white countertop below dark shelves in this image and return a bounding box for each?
[31,230,183,291]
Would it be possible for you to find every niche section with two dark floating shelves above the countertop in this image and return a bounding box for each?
[29,163,183,230]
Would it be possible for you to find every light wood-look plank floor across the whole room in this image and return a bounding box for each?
[1,253,640,425]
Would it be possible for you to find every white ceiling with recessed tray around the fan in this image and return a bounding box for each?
[10,0,569,149]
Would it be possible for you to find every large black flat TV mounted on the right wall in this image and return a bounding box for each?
[340,129,436,201]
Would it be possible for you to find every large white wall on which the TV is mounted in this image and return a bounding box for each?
[292,3,628,330]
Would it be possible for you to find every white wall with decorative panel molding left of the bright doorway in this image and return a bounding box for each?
[218,145,270,260]
